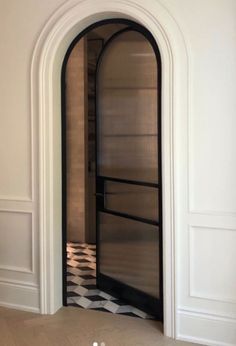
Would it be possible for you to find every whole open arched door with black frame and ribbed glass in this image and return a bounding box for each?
[96,28,162,318]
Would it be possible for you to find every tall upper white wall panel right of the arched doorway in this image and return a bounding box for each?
[187,10,236,215]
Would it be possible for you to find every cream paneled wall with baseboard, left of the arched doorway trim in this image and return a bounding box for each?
[0,0,63,311]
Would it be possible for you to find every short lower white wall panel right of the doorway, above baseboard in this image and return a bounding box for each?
[189,226,236,303]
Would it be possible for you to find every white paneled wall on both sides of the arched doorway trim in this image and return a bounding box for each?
[0,0,236,345]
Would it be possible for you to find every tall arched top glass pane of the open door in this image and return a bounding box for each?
[97,31,158,182]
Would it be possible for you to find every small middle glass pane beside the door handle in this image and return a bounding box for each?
[105,181,159,221]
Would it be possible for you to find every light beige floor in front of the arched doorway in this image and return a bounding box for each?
[0,307,199,346]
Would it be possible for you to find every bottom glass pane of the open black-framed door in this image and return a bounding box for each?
[99,213,160,298]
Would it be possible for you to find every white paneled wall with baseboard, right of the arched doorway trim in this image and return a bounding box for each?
[168,0,236,345]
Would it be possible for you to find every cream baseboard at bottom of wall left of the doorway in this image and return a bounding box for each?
[0,281,40,313]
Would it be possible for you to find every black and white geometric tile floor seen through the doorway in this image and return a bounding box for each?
[67,242,153,319]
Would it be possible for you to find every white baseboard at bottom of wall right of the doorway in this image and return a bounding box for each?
[176,309,236,346]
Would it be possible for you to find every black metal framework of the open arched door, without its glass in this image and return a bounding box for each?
[95,23,163,320]
